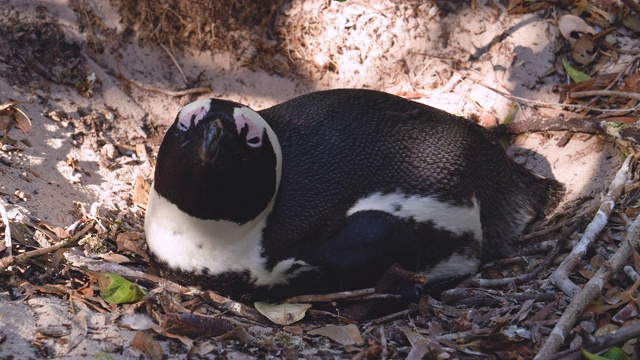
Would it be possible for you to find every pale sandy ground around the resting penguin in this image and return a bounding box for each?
[0,0,632,359]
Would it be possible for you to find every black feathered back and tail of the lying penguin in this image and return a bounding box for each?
[259,90,562,266]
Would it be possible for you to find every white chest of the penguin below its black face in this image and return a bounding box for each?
[145,187,312,286]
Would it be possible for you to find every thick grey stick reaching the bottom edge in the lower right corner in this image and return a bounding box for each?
[534,214,640,360]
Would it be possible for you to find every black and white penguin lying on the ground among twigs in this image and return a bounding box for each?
[145,89,563,300]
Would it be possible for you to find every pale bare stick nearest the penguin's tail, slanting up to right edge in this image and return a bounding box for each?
[550,156,632,296]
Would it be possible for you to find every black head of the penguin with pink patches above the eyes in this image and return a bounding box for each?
[154,99,282,224]
